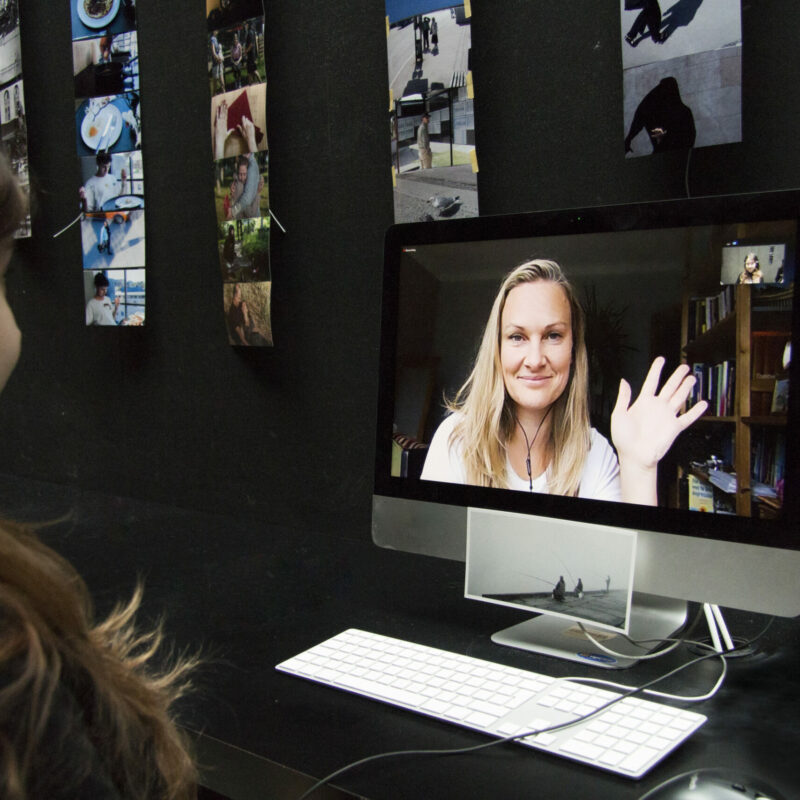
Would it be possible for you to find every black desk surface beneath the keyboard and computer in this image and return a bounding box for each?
[0,476,800,800]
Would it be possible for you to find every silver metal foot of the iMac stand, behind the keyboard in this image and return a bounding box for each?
[492,592,687,669]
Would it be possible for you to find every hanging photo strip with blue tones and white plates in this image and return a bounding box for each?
[69,0,146,327]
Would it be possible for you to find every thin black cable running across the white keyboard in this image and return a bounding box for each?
[297,617,775,800]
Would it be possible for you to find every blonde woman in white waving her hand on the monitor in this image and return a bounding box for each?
[421,260,707,505]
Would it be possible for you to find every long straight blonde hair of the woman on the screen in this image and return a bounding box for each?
[447,259,590,495]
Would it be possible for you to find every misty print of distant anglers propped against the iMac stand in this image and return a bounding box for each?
[464,509,636,632]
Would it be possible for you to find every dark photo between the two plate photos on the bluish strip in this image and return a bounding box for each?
[72,31,139,97]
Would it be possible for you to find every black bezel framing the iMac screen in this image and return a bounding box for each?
[374,191,800,550]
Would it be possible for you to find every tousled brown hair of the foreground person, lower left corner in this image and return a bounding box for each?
[0,522,197,800]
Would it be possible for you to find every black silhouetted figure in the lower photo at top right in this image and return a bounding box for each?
[625,77,696,153]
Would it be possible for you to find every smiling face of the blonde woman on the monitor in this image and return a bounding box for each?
[500,280,572,422]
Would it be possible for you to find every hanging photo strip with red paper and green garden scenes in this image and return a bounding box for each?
[206,0,272,347]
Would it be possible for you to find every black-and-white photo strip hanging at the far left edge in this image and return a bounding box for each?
[0,0,31,238]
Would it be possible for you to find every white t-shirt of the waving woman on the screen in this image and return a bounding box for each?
[421,412,622,501]
